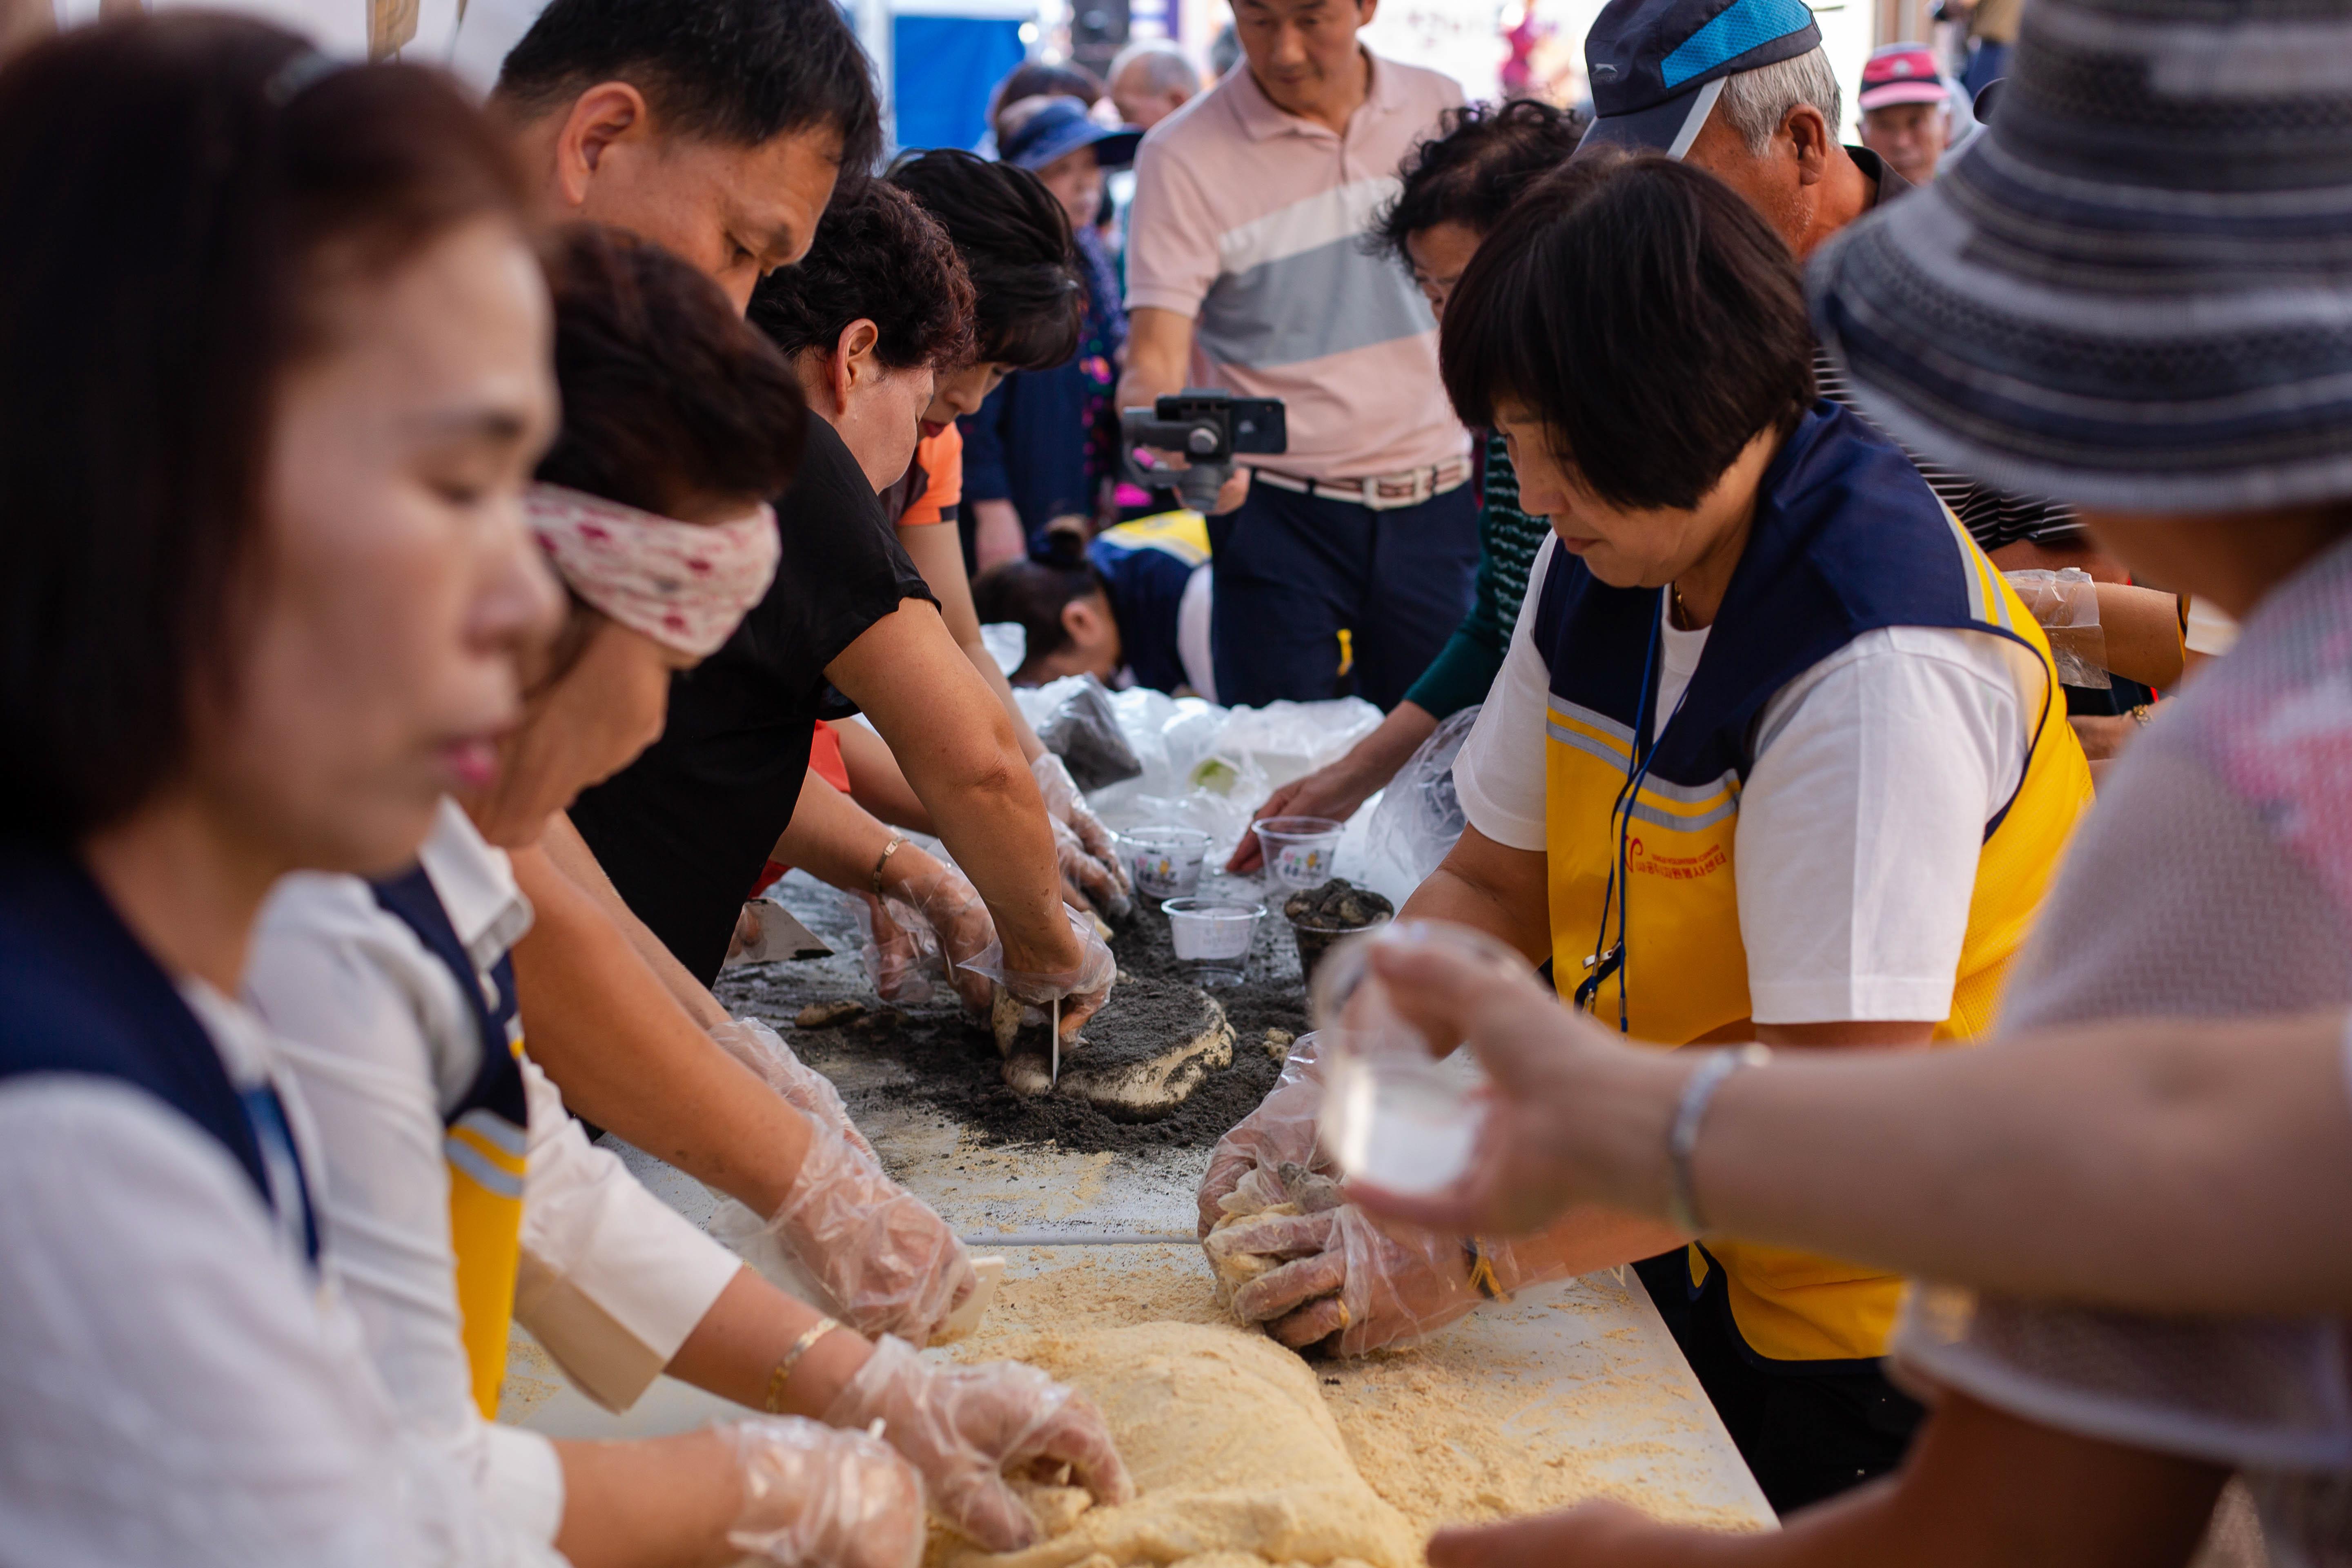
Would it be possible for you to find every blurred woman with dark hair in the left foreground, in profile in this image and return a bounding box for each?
[0,16,941,1568]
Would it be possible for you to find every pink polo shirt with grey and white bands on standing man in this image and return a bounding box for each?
[1127,49,1468,479]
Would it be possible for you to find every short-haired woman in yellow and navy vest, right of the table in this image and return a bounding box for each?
[1204,158,2091,1509]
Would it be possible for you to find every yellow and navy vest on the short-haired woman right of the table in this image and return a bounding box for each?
[1536,404,2091,1361]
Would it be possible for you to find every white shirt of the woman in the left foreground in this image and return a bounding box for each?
[0,980,562,1568]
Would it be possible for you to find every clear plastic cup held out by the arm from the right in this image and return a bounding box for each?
[1312,919,1526,1194]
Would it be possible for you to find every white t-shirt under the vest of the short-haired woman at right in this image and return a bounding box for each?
[1454,538,2042,1022]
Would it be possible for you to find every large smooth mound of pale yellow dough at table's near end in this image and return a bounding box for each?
[936,1323,1421,1568]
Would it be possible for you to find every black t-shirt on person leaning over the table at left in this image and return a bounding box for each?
[572,416,938,985]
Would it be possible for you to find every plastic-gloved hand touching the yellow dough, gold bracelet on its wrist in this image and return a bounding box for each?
[826,1340,1136,1552]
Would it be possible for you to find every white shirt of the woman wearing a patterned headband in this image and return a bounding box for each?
[247,802,741,1542]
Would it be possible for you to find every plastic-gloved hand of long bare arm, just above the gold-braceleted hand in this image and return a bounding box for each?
[767,1124,978,1345]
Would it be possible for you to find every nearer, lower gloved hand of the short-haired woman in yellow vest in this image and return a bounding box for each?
[1218,1204,1524,1356]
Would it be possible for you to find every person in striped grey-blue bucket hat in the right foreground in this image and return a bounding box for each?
[1307,0,2352,1568]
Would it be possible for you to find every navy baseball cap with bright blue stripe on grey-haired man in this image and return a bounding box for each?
[1576,0,1820,158]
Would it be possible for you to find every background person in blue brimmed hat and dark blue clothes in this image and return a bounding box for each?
[957,96,1143,569]
